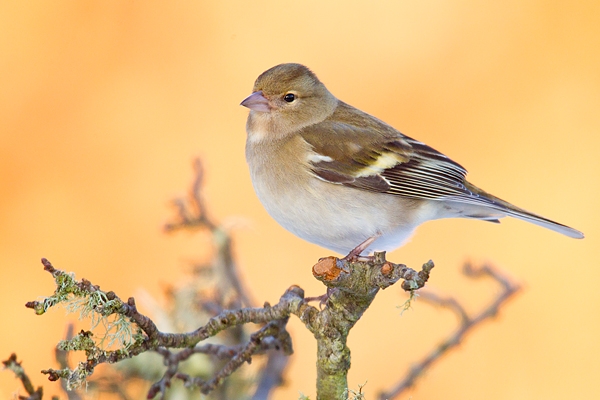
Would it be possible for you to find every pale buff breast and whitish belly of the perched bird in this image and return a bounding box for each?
[246,137,432,253]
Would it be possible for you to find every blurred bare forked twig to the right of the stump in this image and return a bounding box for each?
[379,264,521,400]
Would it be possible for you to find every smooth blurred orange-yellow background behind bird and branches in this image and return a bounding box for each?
[0,0,600,400]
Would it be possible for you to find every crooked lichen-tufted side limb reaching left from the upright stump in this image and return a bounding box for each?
[26,259,304,396]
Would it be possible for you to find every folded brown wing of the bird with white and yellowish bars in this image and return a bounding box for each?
[301,103,478,203]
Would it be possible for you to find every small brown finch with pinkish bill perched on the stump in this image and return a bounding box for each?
[241,63,584,256]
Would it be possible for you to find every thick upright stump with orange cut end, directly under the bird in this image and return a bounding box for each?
[297,253,433,399]
